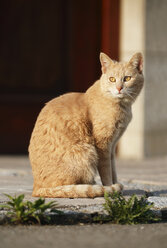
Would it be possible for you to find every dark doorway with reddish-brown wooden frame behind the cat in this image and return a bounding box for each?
[0,0,119,154]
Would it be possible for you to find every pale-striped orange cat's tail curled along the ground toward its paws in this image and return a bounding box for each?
[32,184,123,198]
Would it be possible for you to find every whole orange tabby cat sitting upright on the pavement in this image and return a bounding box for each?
[29,53,144,198]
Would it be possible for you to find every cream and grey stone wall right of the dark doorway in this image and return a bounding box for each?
[119,0,167,159]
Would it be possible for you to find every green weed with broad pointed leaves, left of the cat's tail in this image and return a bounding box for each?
[0,194,60,224]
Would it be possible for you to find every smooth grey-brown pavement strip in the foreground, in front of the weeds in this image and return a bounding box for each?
[0,223,167,248]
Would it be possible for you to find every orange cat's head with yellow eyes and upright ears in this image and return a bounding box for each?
[100,53,144,102]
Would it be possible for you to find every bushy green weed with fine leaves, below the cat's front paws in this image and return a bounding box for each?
[96,192,160,224]
